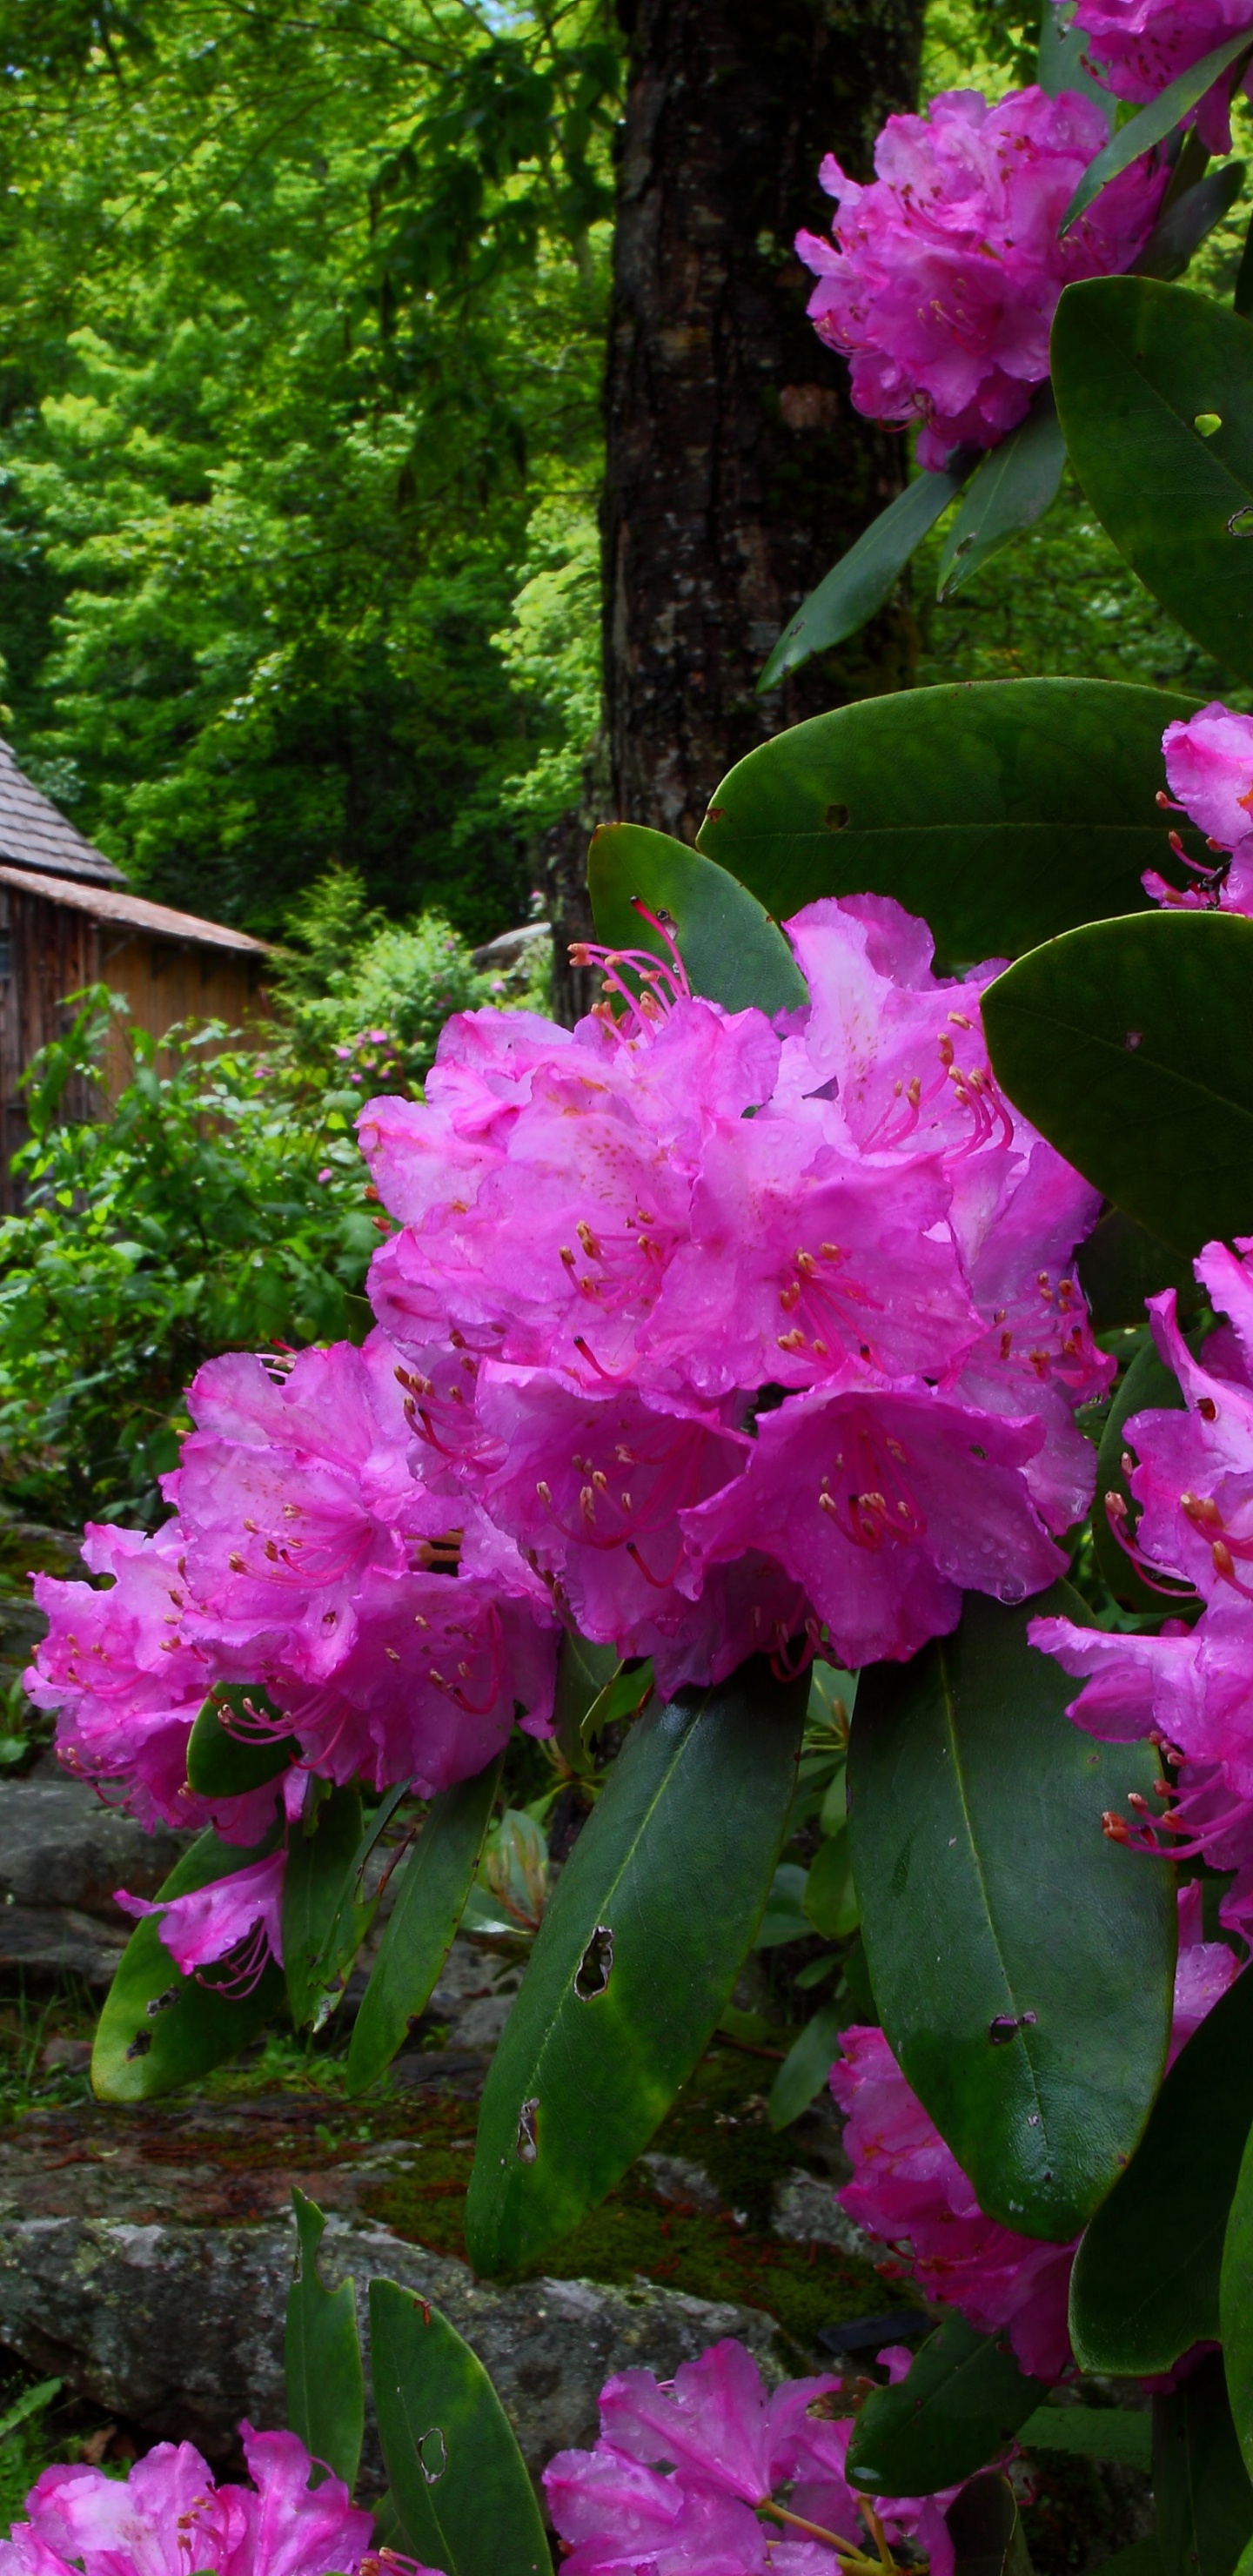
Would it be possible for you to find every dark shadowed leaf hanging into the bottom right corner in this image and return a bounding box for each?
[1152,2351,1253,2576]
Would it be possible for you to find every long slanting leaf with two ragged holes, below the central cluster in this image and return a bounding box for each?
[466,1656,809,2272]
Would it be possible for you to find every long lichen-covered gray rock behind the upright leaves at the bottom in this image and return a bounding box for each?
[0,2216,779,2488]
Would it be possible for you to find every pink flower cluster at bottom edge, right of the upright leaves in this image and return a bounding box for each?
[544,2342,956,2576]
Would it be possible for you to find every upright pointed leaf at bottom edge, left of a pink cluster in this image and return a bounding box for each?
[369,2280,552,2576]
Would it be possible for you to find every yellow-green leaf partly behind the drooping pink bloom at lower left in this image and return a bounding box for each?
[90,1835,284,2102]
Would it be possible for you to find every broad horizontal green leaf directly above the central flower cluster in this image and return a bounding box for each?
[696,680,1202,966]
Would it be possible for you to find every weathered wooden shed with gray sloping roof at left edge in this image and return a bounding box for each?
[0,741,271,1208]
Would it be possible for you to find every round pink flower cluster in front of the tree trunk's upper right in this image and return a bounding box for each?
[797,88,1165,466]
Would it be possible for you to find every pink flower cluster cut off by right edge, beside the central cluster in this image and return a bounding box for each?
[1029,1239,1253,1937]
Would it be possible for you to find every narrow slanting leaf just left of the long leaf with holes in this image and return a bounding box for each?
[345,1752,506,2094]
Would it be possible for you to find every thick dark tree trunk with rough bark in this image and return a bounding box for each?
[549,0,923,1010]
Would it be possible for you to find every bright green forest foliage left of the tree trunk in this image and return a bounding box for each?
[0,0,613,937]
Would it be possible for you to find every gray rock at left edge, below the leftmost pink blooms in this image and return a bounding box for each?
[0,1774,188,1940]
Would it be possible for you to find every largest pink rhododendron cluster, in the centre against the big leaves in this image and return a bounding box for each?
[360,896,1111,1690]
